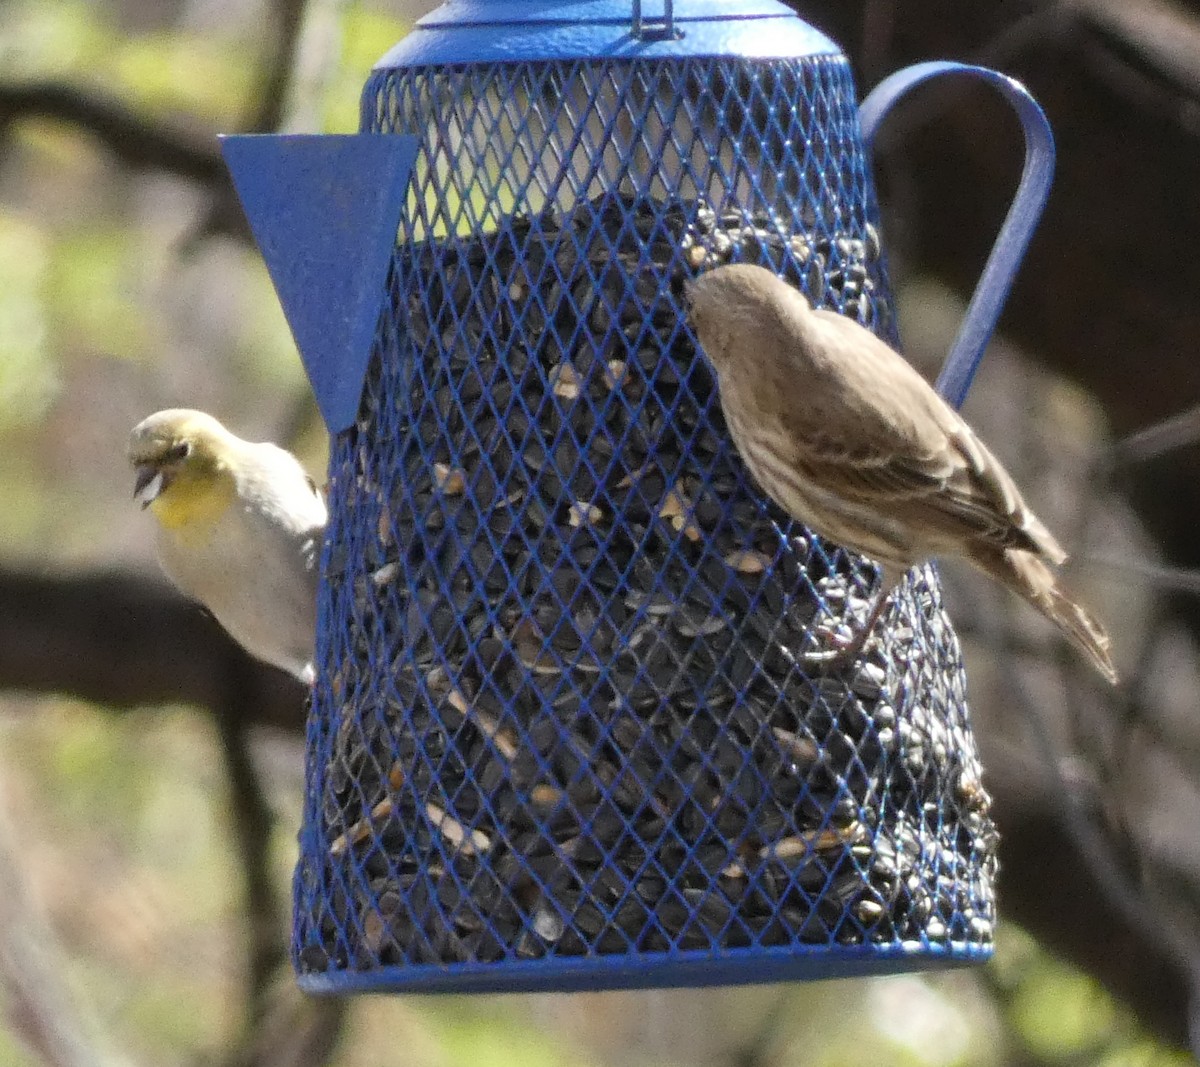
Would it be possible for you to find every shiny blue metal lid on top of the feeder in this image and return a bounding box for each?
[376,0,841,70]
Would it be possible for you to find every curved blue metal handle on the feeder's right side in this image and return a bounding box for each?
[858,61,1055,407]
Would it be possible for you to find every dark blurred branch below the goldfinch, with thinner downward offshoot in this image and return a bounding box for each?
[0,571,344,1067]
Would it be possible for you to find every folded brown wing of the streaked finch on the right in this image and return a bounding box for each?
[782,311,1066,563]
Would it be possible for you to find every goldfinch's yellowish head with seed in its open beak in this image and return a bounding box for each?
[130,408,235,520]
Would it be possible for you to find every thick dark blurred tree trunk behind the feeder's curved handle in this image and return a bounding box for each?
[791,0,1200,633]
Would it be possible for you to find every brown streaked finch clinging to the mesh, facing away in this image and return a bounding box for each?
[686,264,1117,684]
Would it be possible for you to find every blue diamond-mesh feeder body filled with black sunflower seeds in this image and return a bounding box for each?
[294,58,995,990]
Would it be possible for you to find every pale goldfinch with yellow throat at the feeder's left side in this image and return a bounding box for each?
[130,408,326,684]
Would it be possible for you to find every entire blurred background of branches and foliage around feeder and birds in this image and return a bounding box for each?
[0,0,1200,1067]
